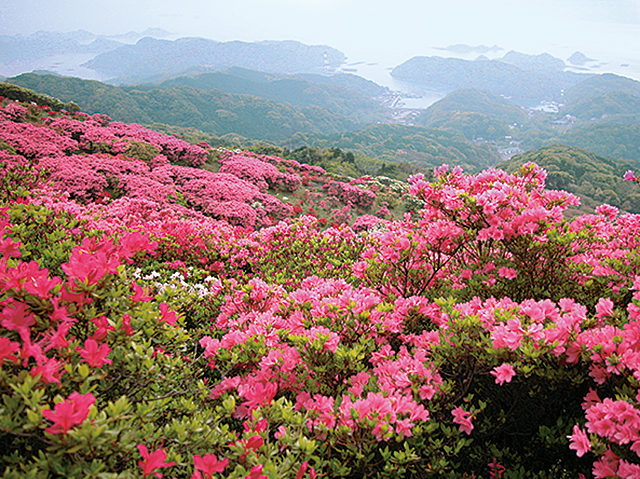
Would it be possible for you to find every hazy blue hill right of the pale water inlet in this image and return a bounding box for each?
[391,52,587,106]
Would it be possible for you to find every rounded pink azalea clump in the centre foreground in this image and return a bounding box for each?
[201,278,442,441]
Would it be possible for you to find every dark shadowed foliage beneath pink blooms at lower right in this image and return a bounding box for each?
[438,308,592,479]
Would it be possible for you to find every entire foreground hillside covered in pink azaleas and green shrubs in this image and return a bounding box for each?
[0,97,640,479]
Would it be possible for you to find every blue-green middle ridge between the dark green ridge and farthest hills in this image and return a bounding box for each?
[151,67,386,123]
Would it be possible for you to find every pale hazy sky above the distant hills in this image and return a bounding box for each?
[0,0,640,69]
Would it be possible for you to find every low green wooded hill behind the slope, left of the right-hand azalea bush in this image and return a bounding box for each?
[302,124,500,173]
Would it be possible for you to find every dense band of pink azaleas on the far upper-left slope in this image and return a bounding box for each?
[0,103,300,227]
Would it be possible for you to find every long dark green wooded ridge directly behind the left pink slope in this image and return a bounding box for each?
[7,74,361,141]
